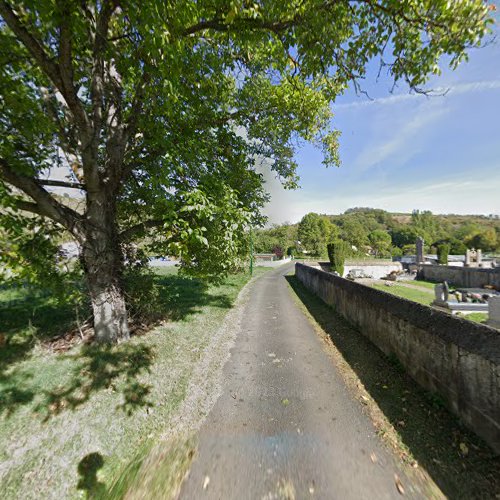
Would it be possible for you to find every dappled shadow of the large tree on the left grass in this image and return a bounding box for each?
[0,274,233,420]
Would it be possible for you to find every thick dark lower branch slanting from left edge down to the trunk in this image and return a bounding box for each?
[0,158,81,236]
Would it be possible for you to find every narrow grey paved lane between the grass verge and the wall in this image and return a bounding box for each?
[180,265,424,500]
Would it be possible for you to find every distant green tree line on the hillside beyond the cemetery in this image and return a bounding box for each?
[254,207,500,258]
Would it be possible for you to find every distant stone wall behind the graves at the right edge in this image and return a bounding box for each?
[418,264,500,289]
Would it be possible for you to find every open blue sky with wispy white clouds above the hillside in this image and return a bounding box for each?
[266,2,500,223]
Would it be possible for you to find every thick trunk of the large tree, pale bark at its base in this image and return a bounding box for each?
[82,193,130,343]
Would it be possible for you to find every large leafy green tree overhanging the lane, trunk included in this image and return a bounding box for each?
[0,0,489,341]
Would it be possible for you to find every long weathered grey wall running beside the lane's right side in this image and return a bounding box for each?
[295,264,500,453]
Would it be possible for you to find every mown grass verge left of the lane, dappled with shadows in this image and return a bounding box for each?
[0,268,263,499]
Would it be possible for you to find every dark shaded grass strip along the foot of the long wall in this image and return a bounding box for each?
[286,276,500,498]
